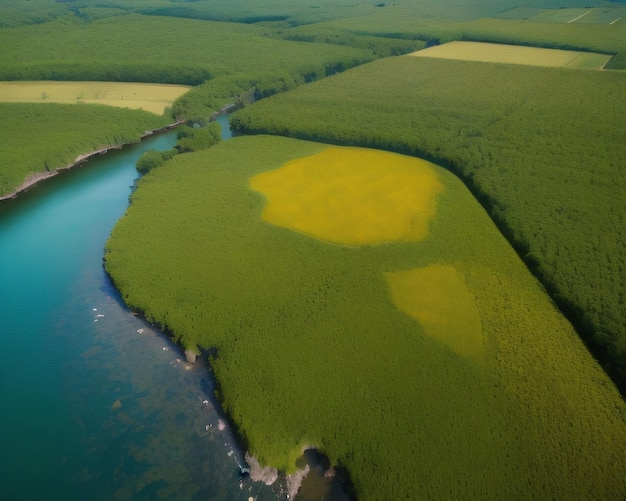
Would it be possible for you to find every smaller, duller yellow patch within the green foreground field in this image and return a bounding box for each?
[385,264,484,357]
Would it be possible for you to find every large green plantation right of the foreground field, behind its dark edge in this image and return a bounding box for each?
[232,56,626,388]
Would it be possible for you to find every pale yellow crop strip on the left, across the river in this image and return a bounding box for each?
[0,81,190,115]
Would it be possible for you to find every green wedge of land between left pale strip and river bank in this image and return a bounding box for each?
[0,103,172,195]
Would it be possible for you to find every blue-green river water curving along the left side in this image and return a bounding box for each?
[0,133,276,500]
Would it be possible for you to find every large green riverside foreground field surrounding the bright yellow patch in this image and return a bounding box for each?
[105,135,626,499]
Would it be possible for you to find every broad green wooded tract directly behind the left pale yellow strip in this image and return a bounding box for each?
[0,14,375,85]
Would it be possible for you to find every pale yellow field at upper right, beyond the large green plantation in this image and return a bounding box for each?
[409,42,612,70]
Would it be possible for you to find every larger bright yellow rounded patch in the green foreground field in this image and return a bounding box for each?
[250,147,443,245]
